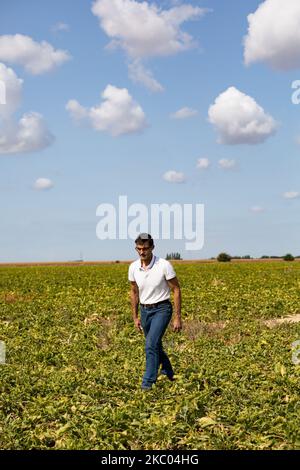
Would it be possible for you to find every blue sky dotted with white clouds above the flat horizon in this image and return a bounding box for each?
[0,0,300,262]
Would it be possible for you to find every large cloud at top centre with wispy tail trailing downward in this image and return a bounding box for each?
[92,0,209,91]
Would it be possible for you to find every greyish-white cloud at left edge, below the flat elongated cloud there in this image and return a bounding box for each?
[0,64,54,154]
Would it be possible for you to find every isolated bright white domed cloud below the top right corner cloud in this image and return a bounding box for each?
[208,87,277,145]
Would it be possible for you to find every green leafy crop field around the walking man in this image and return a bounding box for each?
[0,261,300,450]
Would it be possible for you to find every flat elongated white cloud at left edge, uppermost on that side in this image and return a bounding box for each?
[0,34,71,75]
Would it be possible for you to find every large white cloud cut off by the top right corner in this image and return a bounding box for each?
[244,0,300,70]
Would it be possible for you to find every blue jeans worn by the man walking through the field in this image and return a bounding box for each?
[141,302,174,387]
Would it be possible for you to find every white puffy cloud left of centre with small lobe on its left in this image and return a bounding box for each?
[66,85,147,137]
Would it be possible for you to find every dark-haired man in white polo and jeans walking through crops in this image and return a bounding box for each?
[128,233,182,390]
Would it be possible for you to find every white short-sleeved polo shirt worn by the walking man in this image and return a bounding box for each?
[128,255,176,304]
